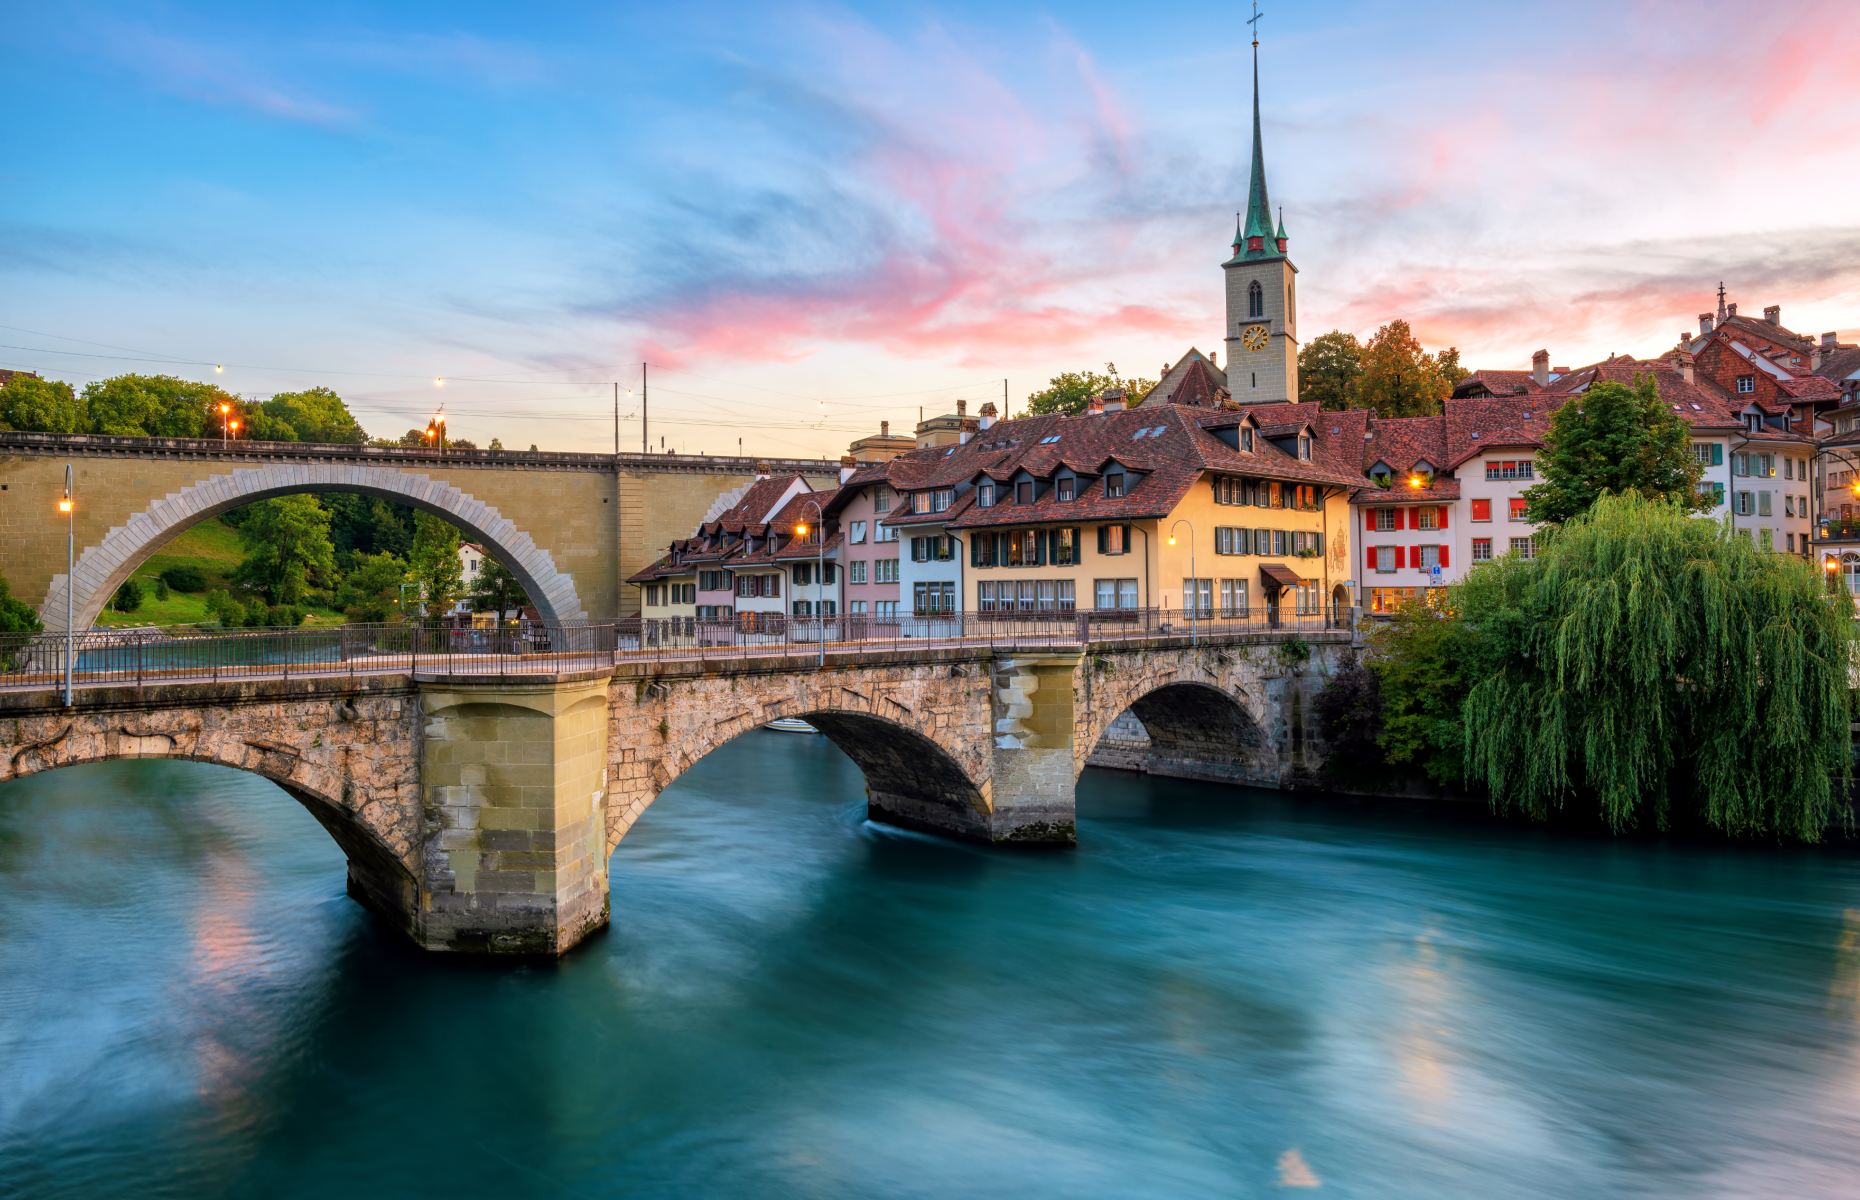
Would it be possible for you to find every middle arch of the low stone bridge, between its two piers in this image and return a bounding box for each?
[606,679,991,854]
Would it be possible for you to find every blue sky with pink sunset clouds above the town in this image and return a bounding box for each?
[0,0,1860,458]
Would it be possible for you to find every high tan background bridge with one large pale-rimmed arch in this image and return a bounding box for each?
[0,432,839,633]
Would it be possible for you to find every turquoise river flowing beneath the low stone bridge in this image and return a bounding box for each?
[0,731,1860,1200]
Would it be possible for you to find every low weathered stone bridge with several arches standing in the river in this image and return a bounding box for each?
[0,620,1350,954]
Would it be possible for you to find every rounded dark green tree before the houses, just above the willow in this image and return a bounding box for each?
[1523,376,1711,525]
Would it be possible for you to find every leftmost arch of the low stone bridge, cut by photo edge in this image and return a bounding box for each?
[0,714,419,912]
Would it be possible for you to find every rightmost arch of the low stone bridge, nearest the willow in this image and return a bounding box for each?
[1073,649,1280,785]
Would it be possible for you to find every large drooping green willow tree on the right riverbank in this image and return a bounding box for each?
[1456,493,1854,841]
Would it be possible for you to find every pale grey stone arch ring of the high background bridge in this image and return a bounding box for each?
[39,461,588,633]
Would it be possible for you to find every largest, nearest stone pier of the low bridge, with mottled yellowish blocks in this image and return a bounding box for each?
[396,672,608,954]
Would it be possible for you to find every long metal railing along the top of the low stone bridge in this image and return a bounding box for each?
[0,608,1349,688]
